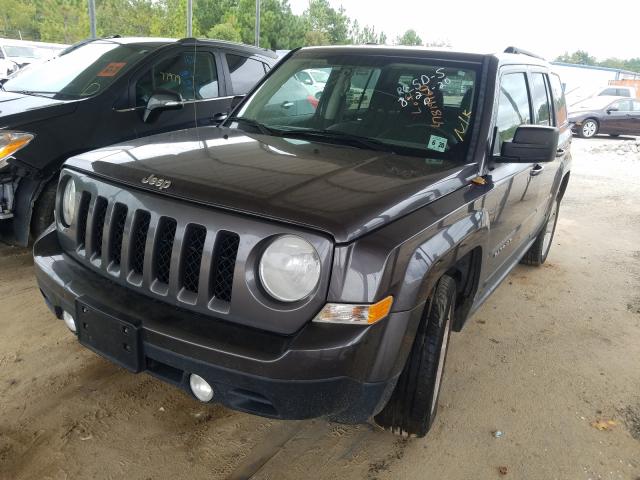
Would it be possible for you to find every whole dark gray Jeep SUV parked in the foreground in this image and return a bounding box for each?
[34,46,571,436]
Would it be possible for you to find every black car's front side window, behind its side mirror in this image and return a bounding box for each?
[136,52,219,107]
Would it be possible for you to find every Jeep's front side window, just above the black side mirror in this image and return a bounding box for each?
[496,73,531,147]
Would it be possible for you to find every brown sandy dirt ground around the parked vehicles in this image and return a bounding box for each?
[0,137,640,480]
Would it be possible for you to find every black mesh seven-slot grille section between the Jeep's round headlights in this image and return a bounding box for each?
[75,191,240,305]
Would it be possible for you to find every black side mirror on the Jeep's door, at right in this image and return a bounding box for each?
[495,125,559,163]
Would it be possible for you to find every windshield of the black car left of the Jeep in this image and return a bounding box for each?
[3,40,148,99]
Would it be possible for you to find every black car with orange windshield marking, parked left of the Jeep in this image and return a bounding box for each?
[0,38,277,245]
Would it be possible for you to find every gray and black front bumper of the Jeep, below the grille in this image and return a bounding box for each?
[34,229,423,422]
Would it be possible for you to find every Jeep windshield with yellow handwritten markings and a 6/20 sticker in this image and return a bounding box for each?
[232,52,478,160]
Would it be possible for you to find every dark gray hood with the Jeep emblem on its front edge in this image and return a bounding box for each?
[66,127,466,243]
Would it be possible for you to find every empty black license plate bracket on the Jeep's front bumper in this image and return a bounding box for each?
[76,302,142,373]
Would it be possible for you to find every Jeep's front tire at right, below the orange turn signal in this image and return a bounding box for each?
[374,275,456,437]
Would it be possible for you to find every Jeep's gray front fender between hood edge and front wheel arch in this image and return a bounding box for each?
[328,185,489,312]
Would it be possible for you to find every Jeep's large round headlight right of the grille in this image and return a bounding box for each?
[260,235,320,302]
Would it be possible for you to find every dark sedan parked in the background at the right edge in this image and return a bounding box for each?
[569,96,640,138]
